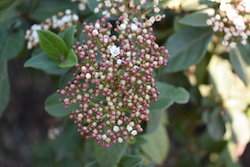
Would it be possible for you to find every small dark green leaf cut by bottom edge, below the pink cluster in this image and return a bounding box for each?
[118,154,143,167]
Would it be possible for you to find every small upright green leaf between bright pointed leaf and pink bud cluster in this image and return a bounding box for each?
[62,25,76,49]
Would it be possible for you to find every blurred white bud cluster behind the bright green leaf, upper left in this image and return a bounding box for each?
[25,9,79,49]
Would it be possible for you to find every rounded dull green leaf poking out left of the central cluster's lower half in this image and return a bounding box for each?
[45,93,79,117]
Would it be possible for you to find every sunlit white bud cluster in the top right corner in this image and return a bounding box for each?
[207,0,250,48]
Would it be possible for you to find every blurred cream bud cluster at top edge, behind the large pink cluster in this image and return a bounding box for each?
[95,0,165,27]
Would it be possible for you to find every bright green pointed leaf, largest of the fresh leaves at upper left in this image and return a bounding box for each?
[37,30,68,60]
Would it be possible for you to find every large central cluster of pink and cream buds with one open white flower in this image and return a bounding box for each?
[57,17,169,147]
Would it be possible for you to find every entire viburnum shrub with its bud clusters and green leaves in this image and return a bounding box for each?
[0,0,250,167]
